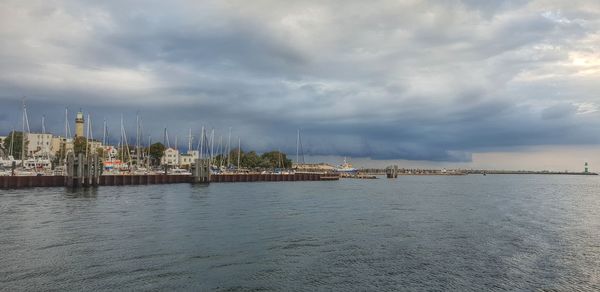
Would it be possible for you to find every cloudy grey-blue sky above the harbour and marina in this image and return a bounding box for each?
[0,0,600,170]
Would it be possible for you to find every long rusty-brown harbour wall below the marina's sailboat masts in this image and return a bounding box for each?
[0,173,339,189]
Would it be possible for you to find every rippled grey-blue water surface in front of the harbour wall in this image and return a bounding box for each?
[0,175,600,291]
